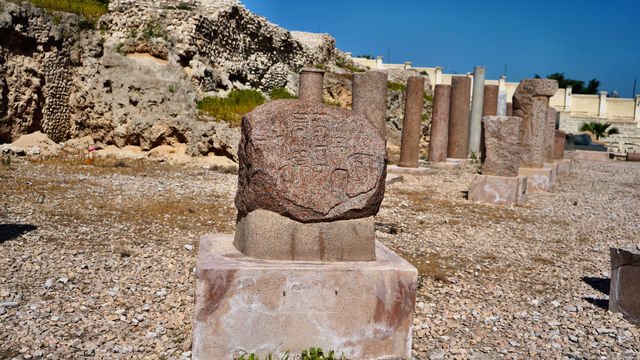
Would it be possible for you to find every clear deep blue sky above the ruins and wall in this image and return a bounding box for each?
[241,0,640,97]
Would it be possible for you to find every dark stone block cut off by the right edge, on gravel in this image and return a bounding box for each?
[609,248,640,324]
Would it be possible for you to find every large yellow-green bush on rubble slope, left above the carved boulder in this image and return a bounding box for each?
[198,90,265,126]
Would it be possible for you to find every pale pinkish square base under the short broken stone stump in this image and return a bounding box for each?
[469,174,527,205]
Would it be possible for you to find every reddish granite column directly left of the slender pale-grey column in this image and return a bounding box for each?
[447,76,471,159]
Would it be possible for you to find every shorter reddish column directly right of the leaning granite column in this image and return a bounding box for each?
[428,84,451,162]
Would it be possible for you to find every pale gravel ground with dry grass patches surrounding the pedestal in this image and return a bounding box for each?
[0,160,640,359]
